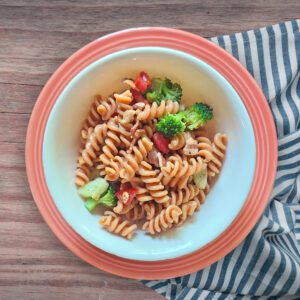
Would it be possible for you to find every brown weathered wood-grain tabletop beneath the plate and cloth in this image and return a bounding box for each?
[0,0,300,300]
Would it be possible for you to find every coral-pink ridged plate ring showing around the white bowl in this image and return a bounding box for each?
[25,27,277,279]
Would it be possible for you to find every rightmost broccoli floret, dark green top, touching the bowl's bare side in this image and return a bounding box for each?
[184,103,213,130]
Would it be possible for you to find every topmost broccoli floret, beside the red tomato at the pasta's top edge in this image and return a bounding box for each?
[146,77,182,104]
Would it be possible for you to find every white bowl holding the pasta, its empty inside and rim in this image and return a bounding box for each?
[43,47,256,261]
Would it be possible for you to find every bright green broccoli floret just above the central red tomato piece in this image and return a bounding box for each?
[156,112,185,138]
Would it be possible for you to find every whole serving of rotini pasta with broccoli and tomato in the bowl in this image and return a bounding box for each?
[75,72,228,239]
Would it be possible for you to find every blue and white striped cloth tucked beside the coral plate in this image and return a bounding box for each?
[143,20,300,299]
